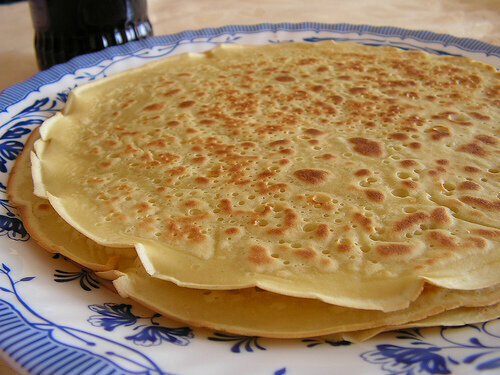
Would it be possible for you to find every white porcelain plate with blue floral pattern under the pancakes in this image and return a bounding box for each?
[0,23,500,375]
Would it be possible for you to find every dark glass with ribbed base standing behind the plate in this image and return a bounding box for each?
[29,0,153,69]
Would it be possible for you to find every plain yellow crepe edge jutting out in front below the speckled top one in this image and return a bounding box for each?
[113,266,500,341]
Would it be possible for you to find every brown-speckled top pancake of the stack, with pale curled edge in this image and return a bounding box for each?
[33,42,500,311]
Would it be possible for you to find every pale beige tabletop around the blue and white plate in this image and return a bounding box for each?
[0,0,500,375]
